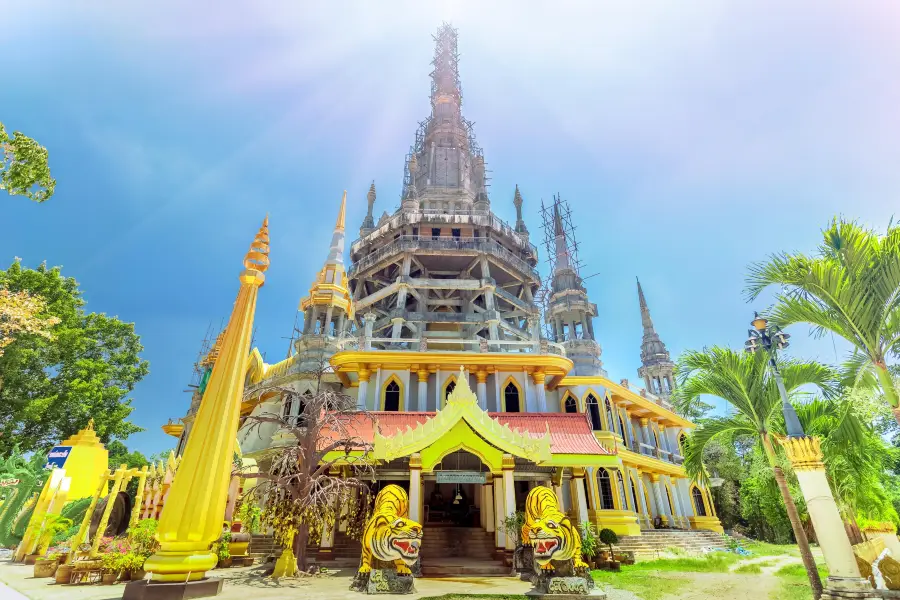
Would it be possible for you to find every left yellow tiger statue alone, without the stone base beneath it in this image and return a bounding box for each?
[359,485,422,575]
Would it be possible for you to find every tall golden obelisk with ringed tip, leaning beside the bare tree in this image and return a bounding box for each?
[144,217,269,597]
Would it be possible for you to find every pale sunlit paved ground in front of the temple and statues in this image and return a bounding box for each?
[0,561,531,600]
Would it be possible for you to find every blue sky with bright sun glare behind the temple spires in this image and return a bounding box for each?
[0,0,900,453]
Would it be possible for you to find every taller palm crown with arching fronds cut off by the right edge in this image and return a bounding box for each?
[746,219,900,424]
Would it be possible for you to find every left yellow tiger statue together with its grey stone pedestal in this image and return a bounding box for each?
[350,485,422,594]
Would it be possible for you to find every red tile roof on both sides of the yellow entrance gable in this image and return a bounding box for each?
[323,412,613,454]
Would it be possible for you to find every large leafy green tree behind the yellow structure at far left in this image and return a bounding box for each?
[0,259,148,454]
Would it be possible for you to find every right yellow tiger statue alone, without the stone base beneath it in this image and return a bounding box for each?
[522,486,587,571]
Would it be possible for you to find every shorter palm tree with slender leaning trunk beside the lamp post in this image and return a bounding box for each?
[675,347,835,599]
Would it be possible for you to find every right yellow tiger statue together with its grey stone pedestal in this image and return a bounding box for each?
[522,486,606,598]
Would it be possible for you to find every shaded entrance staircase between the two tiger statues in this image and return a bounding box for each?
[421,526,510,578]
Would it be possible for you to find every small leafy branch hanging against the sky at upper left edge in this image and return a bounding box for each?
[0,123,56,202]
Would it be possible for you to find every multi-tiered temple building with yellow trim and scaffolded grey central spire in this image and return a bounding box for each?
[165,19,722,566]
